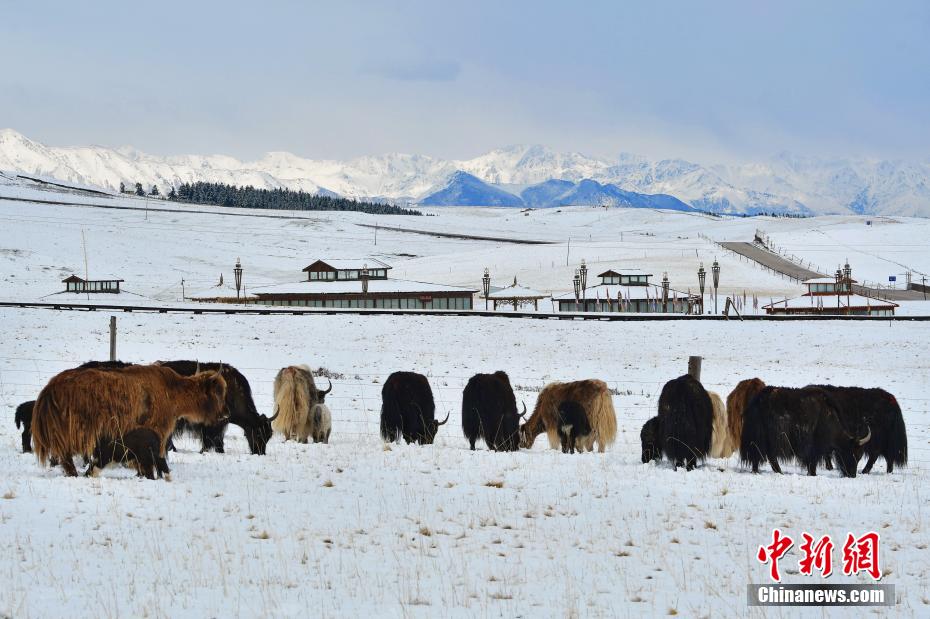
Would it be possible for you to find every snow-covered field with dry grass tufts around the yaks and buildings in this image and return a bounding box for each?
[0,182,930,617]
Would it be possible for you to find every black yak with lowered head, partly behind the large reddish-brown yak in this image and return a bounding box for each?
[158,361,273,456]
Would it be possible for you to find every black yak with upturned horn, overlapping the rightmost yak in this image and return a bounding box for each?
[740,387,872,477]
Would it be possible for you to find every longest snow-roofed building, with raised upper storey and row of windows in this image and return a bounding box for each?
[220,259,478,310]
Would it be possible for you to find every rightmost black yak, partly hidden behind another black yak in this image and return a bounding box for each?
[817,385,907,475]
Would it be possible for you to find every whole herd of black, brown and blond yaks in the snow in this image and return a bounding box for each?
[9,361,907,479]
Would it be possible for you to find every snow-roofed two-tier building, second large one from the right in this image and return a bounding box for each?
[552,265,702,314]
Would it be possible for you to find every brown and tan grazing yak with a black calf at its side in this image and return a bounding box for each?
[520,379,617,452]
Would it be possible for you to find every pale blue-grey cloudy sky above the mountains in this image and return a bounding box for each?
[0,0,930,162]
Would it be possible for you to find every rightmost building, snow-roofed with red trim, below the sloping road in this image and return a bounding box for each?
[762,274,898,316]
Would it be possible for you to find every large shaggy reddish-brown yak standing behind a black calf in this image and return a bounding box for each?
[32,365,226,476]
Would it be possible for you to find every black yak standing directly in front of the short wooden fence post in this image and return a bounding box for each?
[644,374,714,471]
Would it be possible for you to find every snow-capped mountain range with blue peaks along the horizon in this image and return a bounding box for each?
[0,129,930,217]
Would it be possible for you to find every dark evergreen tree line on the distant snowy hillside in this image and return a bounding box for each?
[167,182,423,215]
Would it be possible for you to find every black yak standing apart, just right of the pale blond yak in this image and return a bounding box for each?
[381,372,449,445]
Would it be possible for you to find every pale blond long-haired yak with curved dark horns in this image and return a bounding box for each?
[271,365,333,443]
